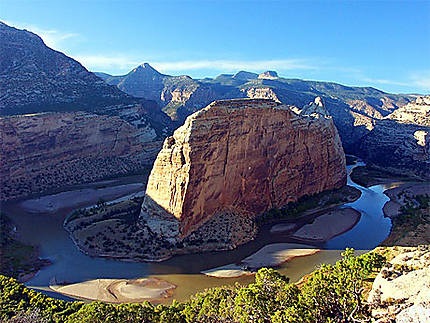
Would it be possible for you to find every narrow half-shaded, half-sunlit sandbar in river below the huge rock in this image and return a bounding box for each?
[202,243,320,278]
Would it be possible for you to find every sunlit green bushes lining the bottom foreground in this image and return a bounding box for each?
[0,249,385,323]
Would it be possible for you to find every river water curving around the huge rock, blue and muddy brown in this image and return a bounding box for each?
[3,162,397,301]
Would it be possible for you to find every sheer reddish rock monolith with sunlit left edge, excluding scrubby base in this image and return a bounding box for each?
[141,99,346,239]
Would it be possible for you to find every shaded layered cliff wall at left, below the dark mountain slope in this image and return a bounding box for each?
[0,109,162,200]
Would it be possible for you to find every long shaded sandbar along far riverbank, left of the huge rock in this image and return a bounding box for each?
[20,183,144,213]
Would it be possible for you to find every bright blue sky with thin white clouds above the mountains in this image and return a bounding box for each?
[0,0,430,93]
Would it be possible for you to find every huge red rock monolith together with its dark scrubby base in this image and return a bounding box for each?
[65,98,351,261]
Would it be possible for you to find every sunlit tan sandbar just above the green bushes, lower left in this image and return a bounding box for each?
[49,278,176,303]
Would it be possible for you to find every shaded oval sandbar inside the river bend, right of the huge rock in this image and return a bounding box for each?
[292,207,361,242]
